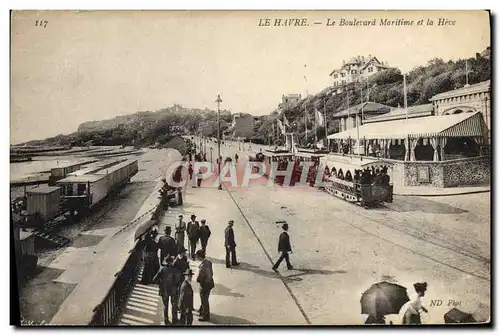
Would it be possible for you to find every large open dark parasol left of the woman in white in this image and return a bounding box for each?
[360,282,410,316]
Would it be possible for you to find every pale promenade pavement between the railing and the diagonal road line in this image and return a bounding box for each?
[120,186,306,326]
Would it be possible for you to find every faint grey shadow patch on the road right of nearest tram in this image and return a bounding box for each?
[382,196,467,214]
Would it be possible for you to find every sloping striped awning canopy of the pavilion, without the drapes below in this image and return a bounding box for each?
[328,112,487,140]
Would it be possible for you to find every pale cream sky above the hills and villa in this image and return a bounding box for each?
[10,11,490,144]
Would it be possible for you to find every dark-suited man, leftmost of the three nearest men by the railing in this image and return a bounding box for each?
[153,256,182,325]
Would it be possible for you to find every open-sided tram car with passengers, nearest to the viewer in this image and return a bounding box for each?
[323,157,393,208]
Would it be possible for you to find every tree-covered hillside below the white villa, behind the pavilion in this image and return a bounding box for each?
[258,53,491,143]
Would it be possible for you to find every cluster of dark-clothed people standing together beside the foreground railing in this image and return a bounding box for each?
[141,214,215,325]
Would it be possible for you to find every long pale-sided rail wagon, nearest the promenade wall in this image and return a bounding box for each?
[57,160,139,209]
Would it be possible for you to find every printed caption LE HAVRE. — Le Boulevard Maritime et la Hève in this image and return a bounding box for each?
[258,18,456,27]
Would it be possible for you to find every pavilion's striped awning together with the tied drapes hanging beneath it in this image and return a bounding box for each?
[327,112,488,161]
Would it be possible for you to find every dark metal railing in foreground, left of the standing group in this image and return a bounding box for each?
[90,242,144,326]
